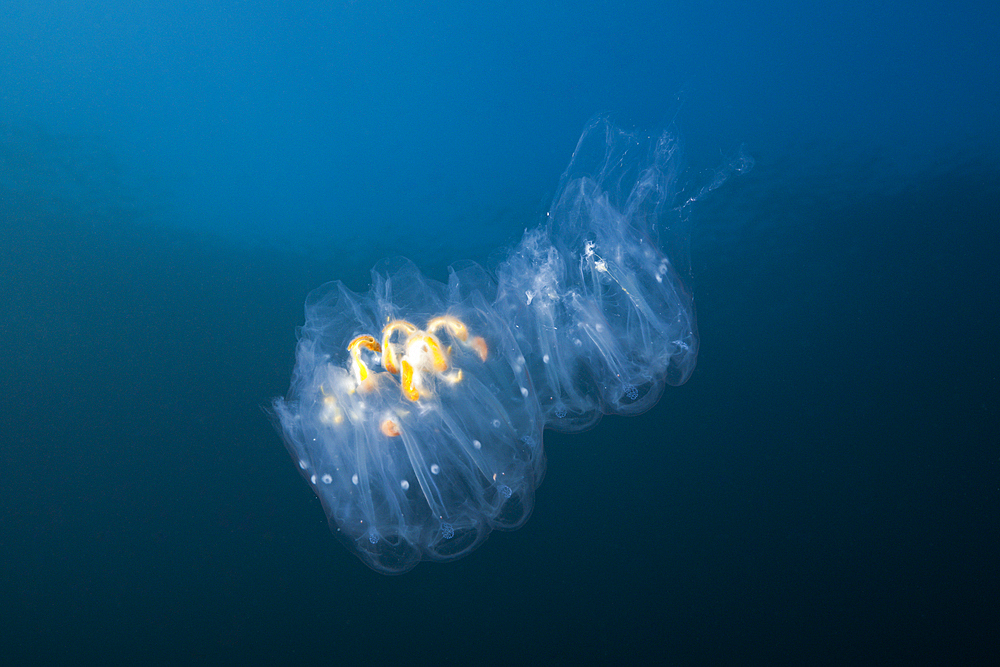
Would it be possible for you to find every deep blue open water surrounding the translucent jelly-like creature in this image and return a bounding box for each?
[0,0,1000,665]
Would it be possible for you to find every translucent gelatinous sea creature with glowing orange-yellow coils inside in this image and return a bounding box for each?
[274,120,728,573]
